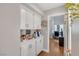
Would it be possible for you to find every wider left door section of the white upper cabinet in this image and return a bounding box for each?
[21,9,33,29]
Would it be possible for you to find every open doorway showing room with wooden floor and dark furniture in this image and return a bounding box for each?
[49,15,64,56]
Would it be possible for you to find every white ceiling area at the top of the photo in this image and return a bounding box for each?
[34,3,64,11]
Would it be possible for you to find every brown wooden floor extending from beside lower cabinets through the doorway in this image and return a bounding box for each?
[39,39,64,56]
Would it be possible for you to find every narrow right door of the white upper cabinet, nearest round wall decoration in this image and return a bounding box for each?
[34,13,41,29]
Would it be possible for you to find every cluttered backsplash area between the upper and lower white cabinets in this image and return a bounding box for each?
[20,29,41,41]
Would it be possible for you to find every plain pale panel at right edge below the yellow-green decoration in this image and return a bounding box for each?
[71,18,79,56]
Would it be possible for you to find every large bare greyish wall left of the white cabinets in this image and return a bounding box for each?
[0,4,20,56]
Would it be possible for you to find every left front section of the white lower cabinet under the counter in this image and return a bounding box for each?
[21,39,36,56]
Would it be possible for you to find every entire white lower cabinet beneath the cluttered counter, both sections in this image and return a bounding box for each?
[21,37,43,56]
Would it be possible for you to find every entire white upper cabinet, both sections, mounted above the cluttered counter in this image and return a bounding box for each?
[21,6,41,29]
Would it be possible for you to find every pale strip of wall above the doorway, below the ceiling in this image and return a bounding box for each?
[45,6,67,16]
